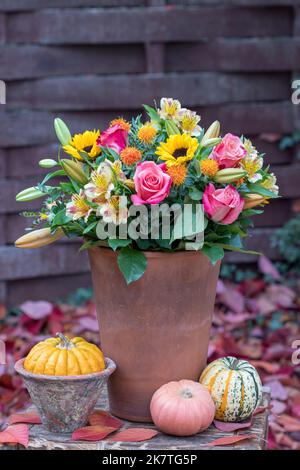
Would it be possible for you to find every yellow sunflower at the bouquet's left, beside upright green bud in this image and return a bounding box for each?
[63,130,101,160]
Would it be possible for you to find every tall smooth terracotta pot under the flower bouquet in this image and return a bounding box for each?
[89,248,220,422]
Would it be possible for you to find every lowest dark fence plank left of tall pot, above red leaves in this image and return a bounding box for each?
[6,272,91,307]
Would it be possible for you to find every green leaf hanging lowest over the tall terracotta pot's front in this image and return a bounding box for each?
[118,247,147,284]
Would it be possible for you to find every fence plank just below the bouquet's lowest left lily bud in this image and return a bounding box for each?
[0,243,89,281]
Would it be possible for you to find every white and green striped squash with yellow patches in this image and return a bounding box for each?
[199,356,262,422]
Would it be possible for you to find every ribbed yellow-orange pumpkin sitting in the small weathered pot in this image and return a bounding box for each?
[24,333,105,376]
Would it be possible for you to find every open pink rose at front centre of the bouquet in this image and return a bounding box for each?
[131,161,172,205]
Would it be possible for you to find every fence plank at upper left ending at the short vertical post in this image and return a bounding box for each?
[0,44,146,80]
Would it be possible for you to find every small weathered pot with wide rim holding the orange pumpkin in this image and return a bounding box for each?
[15,357,116,433]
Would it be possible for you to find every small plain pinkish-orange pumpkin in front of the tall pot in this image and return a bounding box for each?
[150,380,215,436]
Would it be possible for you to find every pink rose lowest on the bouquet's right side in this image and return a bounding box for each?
[203,183,244,225]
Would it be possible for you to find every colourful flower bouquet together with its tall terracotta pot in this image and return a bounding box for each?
[16,98,278,420]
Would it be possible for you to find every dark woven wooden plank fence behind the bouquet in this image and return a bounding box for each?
[0,0,300,304]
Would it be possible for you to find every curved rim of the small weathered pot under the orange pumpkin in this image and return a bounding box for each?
[15,357,117,383]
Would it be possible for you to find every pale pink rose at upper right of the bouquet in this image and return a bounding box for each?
[211,134,247,170]
